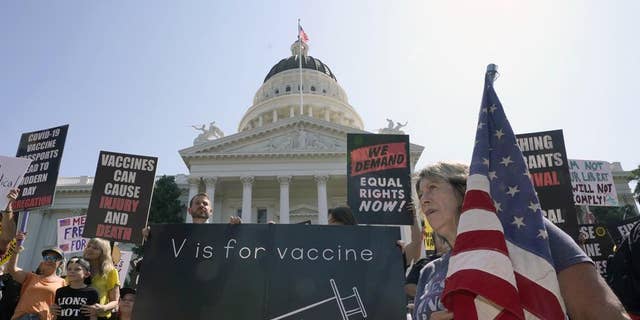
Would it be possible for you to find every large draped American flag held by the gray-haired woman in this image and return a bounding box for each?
[442,65,566,319]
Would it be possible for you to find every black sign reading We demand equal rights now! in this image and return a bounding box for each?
[347,133,413,225]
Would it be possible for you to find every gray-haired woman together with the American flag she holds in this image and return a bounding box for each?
[414,64,629,320]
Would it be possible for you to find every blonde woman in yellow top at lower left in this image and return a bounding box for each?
[81,238,120,319]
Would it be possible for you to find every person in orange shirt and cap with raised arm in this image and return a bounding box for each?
[7,232,65,320]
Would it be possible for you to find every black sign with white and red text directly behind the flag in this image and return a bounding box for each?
[516,130,578,240]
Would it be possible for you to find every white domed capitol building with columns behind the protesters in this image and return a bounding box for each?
[20,41,424,270]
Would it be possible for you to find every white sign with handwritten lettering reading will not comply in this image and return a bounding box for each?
[569,159,618,207]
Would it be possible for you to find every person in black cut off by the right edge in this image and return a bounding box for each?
[607,222,640,320]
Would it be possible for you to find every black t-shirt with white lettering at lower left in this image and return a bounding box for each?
[55,286,98,320]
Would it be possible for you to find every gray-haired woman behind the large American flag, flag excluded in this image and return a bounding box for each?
[414,163,628,320]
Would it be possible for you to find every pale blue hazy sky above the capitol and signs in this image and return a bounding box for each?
[0,0,640,176]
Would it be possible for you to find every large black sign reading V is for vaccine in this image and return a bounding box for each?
[133,224,406,320]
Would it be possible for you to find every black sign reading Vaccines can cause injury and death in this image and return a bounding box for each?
[82,151,158,243]
